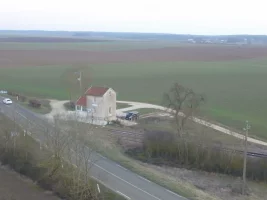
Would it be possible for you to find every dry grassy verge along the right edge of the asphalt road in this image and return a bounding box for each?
[82,128,221,200]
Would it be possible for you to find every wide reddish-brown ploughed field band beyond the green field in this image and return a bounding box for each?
[0,45,267,67]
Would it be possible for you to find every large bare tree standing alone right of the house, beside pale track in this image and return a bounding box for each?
[163,83,205,137]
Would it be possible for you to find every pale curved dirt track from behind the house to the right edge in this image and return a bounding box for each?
[117,101,267,146]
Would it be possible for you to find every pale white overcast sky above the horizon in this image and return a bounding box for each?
[0,0,267,35]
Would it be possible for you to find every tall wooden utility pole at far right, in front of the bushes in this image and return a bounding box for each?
[242,121,251,195]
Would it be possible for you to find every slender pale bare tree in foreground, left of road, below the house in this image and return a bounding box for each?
[56,115,97,200]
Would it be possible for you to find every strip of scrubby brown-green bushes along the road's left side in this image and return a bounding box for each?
[0,115,124,200]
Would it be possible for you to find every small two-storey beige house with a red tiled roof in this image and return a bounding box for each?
[75,87,117,124]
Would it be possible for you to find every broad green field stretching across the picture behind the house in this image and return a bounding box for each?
[0,42,267,140]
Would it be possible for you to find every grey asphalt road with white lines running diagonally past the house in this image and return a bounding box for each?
[0,97,185,200]
